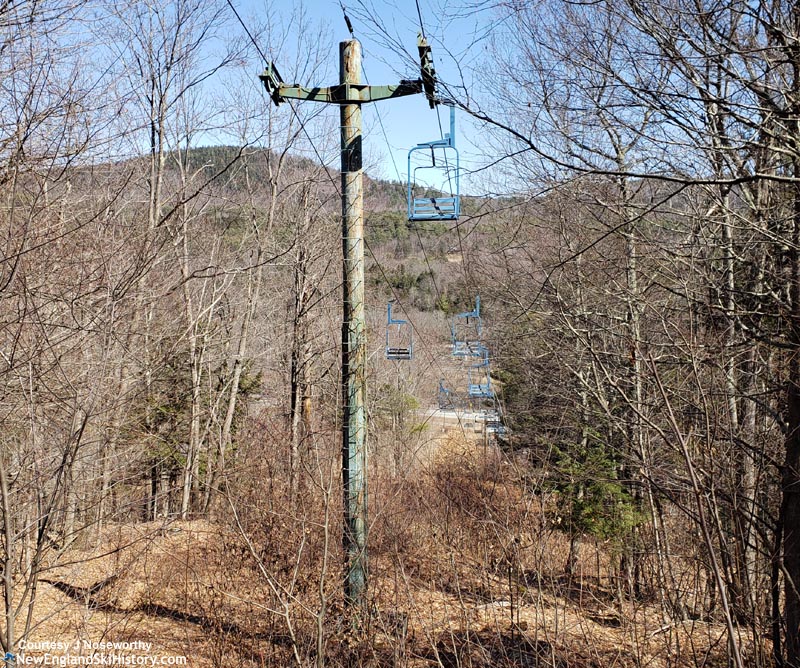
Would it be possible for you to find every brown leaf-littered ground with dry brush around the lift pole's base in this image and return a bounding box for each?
[18,430,764,668]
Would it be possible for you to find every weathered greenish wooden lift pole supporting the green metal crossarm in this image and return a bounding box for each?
[339,40,367,607]
